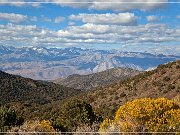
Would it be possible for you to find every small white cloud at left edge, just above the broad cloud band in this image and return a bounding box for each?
[0,13,28,23]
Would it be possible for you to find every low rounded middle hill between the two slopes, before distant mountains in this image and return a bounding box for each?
[54,68,140,91]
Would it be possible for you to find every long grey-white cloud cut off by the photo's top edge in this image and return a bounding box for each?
[47,0,168,11]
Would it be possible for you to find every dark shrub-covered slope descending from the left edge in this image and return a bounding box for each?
[0,71,81,105]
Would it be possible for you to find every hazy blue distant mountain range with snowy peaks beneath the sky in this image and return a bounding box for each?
[0,46,180,80]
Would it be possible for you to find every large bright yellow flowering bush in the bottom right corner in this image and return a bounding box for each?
[100,98,180,132]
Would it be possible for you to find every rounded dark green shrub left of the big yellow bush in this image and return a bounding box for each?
[56,99,96,131]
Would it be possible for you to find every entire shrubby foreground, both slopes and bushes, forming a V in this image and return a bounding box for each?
[0,61,180,132]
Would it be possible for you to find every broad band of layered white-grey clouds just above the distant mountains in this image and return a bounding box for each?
[0,23,180,46]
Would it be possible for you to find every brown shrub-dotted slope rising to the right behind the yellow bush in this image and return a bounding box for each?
[81,60,180,117]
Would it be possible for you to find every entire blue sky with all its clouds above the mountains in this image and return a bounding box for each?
[0,0,180,55]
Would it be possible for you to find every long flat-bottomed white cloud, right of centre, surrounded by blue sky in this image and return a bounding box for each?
[69,12,137,25]
